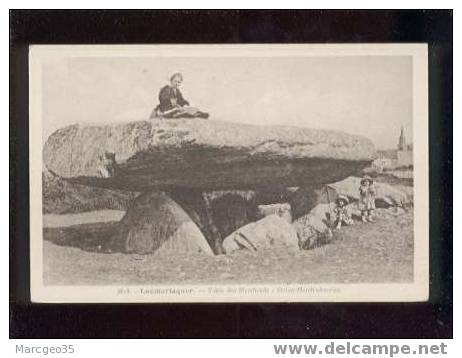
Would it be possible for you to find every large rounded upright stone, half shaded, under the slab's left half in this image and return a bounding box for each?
[117,192,213,255]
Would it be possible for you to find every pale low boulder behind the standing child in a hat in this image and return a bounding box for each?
[329,177,409,207]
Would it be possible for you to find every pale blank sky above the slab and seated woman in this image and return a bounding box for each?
[42,56,412,149]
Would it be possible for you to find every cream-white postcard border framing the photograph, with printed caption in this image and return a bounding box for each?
[29,44,429,303]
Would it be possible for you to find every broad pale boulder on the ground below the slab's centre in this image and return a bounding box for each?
[223,215,299,253]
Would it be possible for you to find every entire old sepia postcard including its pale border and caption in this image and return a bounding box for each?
[29,44,429,302]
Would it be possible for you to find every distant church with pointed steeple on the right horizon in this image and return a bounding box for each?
[372,127,413,171]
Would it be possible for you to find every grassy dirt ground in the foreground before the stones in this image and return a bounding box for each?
[43,207,414,285]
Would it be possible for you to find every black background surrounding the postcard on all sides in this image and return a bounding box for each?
[10,10,453,338]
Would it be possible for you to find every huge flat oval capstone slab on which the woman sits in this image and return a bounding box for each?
[44,119,375,192]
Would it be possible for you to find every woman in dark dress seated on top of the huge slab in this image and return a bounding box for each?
[150,72,209,118]
